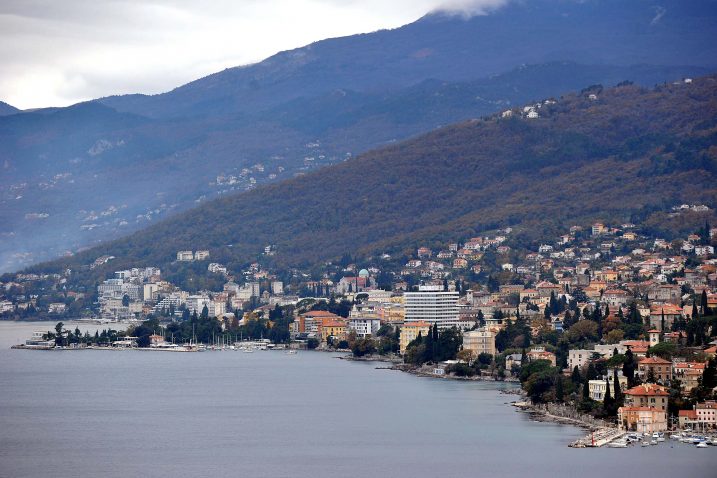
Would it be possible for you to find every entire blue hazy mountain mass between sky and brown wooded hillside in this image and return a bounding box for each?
[0,0,717,271]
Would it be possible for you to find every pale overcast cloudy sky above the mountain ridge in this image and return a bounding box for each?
[0,0,505,109]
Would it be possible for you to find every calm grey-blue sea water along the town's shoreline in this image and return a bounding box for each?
[0,322,717,478]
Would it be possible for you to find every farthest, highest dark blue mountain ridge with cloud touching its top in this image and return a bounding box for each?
[102,0,717,117]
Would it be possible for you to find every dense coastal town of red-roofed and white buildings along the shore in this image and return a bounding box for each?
[0,205,717,434]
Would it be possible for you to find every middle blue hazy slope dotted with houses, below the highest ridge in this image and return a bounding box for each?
[0,62,704,271]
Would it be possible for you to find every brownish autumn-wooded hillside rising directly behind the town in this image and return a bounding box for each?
[30,75,717,285]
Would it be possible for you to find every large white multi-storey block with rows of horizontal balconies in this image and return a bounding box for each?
[404,285,459,329]
